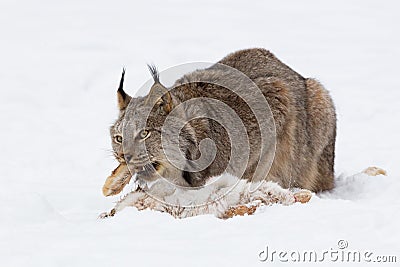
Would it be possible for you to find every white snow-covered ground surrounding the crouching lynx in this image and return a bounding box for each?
[0,0,400,267]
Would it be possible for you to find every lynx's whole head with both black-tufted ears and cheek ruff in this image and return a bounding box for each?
[110,66,195,185]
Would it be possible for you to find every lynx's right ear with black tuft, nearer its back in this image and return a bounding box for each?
[145,65,172,113]
